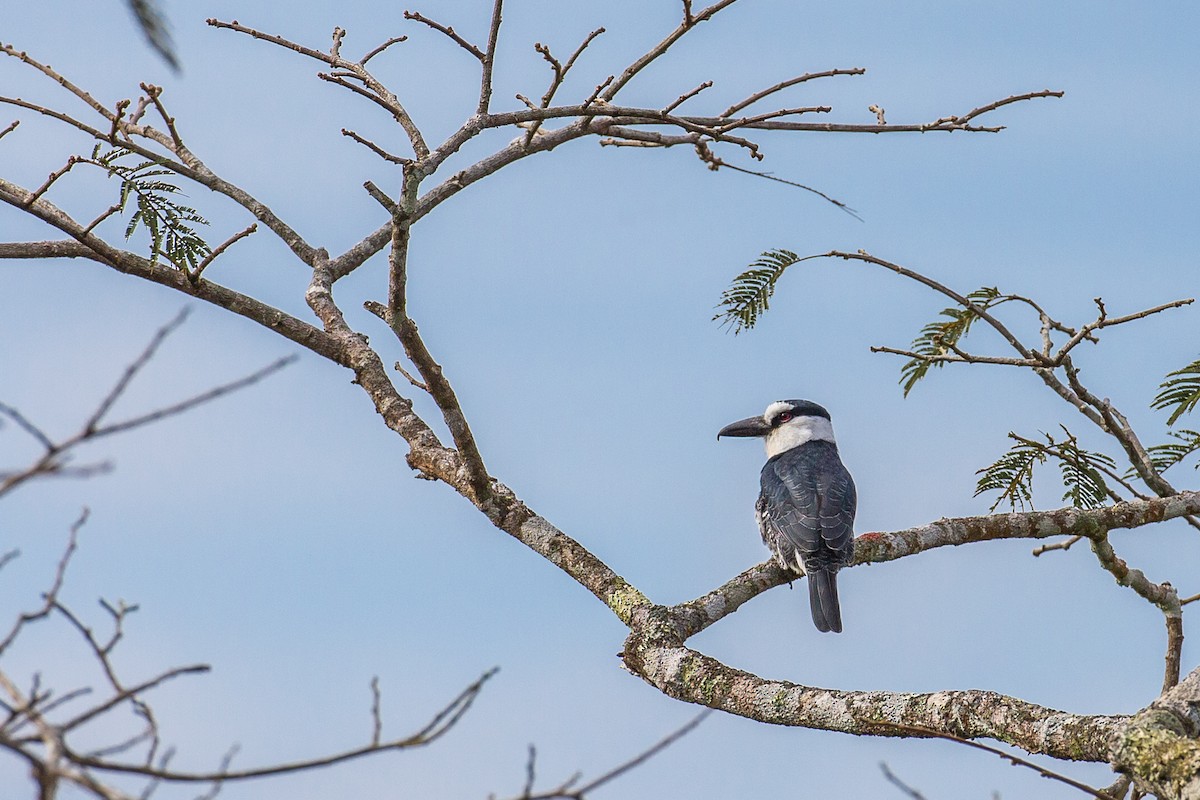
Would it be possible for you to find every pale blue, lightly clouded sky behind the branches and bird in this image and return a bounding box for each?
[0,0,1200,799]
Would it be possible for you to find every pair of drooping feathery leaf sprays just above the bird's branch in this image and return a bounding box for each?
[976,426,1116,511]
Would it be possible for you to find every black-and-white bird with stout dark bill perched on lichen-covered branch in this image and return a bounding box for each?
[716,399,858,633]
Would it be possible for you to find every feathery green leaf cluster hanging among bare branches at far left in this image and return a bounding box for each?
[91,145,212,272]
